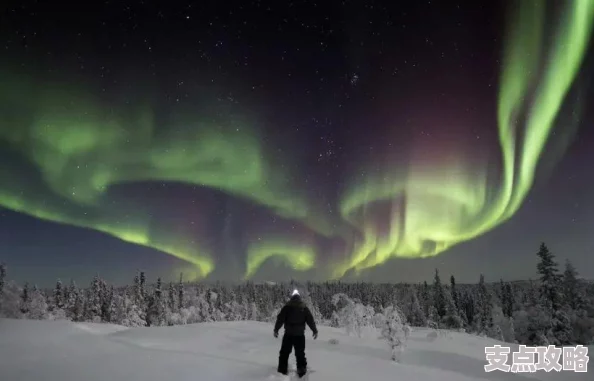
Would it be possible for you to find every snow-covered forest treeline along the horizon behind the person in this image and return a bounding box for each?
[0,243,594,345]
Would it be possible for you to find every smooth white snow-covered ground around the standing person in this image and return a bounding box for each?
[0,319,594,381]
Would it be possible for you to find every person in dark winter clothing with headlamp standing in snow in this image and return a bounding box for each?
[274,290,318,377]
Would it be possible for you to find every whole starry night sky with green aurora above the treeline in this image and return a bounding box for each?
[0,0,594,285]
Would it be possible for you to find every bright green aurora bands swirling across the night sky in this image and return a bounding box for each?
[0,0,594,278]
